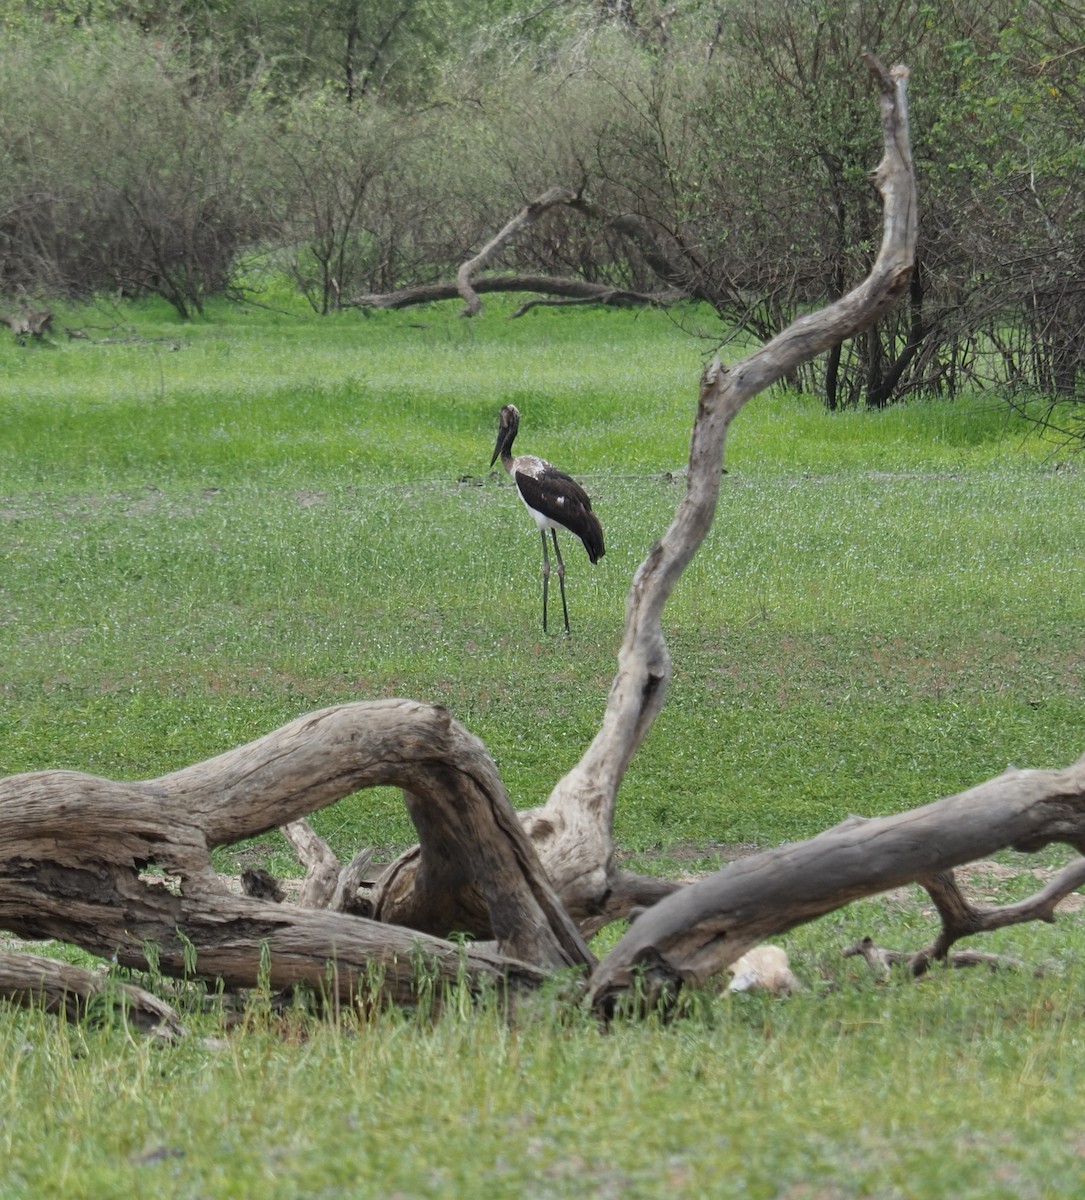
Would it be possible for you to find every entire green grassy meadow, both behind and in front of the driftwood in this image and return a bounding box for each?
[0,296,1085,1200]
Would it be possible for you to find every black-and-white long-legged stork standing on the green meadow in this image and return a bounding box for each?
[490,404,605,634]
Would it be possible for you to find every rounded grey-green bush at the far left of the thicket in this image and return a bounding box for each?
[0,31,257,314]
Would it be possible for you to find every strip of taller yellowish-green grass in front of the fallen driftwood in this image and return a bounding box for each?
[0,926,1085,1200]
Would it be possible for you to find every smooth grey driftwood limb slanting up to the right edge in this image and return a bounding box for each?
[591,757,1085,1010]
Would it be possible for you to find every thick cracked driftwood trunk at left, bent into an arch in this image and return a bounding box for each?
[0,701,593,1002]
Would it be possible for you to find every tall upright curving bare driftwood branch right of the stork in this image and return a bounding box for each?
[526,59,916,940]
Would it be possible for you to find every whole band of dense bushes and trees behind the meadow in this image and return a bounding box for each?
[0,0,1085,407]
